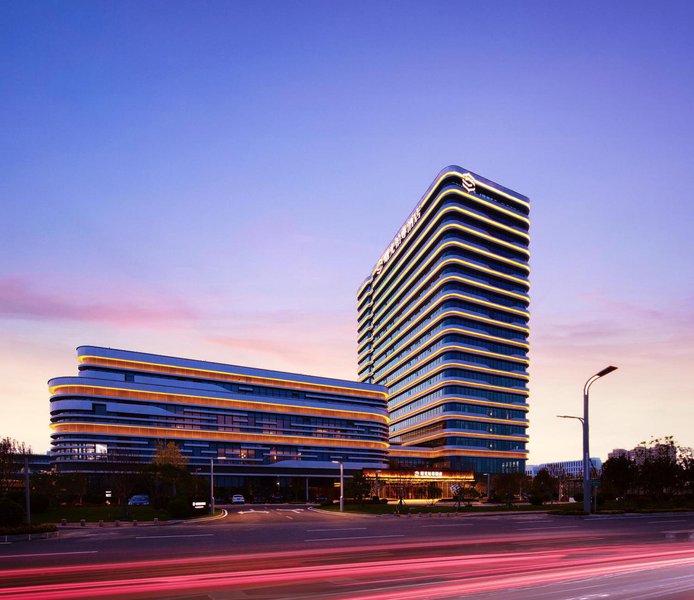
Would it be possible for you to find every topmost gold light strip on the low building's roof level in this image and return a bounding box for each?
[77,354,386,399]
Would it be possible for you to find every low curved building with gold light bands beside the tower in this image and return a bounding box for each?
[49,346,388,474]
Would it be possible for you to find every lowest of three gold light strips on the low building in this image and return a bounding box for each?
[51,422,389,450]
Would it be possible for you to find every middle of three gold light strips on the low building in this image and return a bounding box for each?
[49,384,389,424]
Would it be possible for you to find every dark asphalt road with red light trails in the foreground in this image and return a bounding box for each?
[0,505,694,600]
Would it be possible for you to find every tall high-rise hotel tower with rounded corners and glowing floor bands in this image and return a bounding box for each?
[357,166,530,473]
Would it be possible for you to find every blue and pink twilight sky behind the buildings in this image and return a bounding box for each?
[0,0,694,464]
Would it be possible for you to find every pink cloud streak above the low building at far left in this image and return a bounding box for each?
[0,277,197,327]
